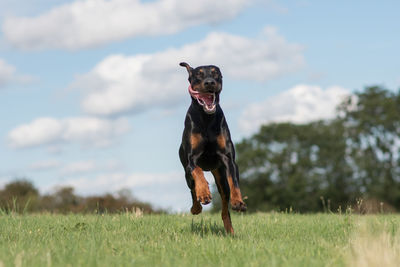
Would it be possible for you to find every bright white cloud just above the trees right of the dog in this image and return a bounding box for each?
[239,85,350,134]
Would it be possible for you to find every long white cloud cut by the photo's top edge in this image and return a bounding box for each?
[3,0,250,49]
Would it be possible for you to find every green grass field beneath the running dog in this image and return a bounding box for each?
[0,213,400,267]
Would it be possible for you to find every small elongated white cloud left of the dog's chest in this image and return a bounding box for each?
[8,117,129,148]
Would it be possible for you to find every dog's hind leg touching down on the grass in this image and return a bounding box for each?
[212,167,234,234]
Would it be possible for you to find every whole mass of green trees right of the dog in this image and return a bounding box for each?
[214,87,400,212]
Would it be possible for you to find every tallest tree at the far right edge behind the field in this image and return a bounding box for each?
[339,86,400,208]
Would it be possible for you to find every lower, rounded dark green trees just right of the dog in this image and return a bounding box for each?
[237,121,358,214]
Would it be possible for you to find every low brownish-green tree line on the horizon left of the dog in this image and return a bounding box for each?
[0,179,159,214]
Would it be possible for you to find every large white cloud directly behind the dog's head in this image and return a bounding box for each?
[73,27,304,115]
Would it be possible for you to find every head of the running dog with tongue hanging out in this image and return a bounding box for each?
[179,62,222,114]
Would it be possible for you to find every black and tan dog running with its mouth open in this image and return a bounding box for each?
[179,62,246,234]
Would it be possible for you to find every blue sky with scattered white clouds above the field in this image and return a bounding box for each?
[0,0,400,212]
